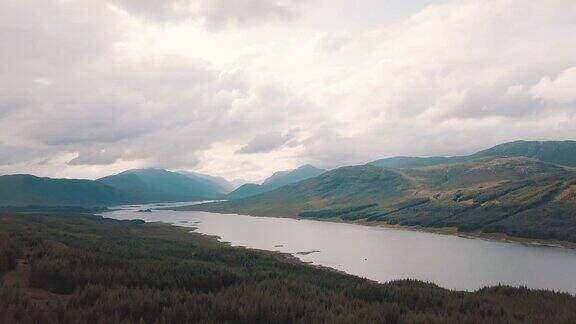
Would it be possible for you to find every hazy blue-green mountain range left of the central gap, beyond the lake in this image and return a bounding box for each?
[0,169,227,207]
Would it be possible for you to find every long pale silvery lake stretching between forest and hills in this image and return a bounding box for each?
[102,203,576,294]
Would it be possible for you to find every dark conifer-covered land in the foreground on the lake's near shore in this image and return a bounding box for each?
[0,215,576,323]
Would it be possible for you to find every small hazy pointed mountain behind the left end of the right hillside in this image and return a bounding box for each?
[226,165,326,200]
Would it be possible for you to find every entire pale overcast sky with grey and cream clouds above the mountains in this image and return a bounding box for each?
[0,0,576,181]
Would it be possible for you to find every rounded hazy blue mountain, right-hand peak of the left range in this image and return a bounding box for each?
[97,169,223,203]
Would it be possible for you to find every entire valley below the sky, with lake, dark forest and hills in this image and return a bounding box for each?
[0,142,576,323]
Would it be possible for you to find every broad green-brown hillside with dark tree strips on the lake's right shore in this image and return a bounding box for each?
[187,157,576,242]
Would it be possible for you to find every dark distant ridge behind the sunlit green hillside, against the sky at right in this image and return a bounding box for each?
[369,141,576,169]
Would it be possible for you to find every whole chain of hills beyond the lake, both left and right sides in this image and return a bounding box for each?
[0,141,576,242]
